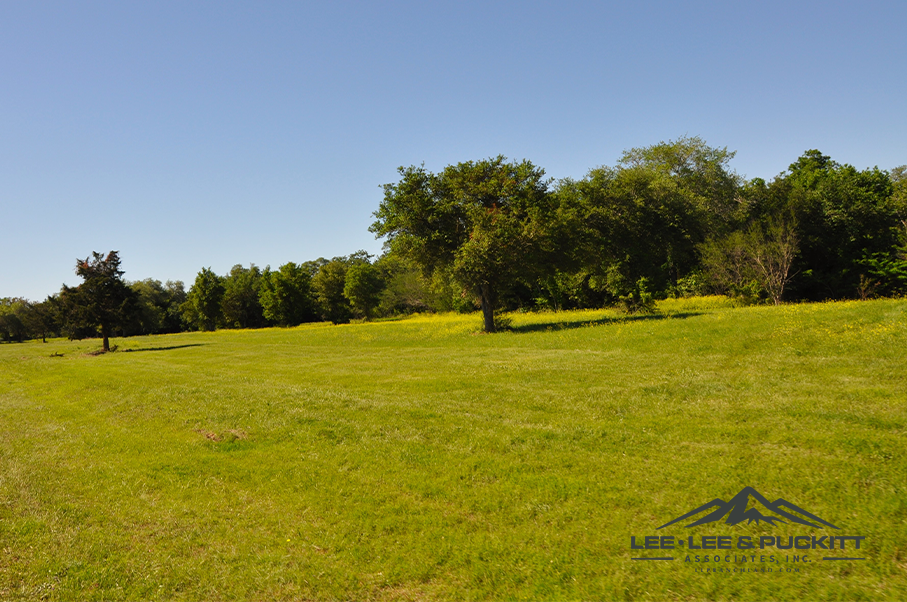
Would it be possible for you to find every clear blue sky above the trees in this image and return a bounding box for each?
[0,0,907,299]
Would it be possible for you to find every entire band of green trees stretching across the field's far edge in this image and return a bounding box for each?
[0,137,907,347]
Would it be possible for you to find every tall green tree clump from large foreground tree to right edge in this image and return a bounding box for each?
[371,142,907,314]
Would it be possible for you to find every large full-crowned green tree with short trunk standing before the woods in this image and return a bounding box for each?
[370,156,555,332]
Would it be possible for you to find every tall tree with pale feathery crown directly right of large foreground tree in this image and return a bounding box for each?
[557,138,739,305]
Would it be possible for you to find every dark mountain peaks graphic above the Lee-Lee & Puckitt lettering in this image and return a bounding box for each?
[656,487,839,530]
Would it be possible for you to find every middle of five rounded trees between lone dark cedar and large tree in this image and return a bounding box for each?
[259,261,316,326]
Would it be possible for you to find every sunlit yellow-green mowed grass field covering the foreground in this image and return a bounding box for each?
[0,298,907,600]
